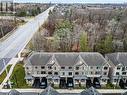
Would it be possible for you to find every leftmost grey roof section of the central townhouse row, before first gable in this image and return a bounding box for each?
[29,53,52,65]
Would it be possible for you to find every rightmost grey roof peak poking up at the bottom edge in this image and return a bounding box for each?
[80,87,102,95]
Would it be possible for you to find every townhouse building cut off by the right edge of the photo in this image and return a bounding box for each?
[105,52,127,88]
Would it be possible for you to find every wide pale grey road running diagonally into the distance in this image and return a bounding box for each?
[0,6,54,72]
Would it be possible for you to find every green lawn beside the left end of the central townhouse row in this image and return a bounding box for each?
[10,62,29,88]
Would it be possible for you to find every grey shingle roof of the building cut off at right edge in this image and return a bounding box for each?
[106,52,127,66]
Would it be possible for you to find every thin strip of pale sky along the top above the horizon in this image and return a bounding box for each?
[0,0,127,3]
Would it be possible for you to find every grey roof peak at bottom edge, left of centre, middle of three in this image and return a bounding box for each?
[40,86,60,95]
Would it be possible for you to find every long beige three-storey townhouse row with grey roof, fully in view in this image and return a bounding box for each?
[24,52,111,88]
